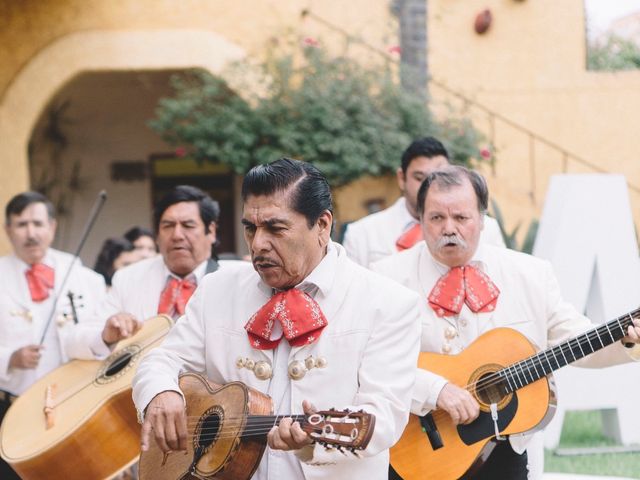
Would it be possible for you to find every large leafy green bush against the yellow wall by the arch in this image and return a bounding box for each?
[150,37,487,187]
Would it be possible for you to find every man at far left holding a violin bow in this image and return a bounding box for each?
[0,192,106,480]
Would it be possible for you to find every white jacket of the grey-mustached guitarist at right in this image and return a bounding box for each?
[372,242,632,452]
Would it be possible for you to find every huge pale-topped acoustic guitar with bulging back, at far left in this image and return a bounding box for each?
[0,315,173,480]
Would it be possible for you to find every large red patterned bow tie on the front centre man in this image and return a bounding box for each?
[244,288,327,350]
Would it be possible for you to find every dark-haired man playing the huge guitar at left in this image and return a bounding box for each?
[94,185,226,346]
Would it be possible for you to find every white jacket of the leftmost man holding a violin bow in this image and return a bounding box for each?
[0,249,106,395]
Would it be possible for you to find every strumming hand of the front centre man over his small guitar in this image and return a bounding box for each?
[140,391,187,453]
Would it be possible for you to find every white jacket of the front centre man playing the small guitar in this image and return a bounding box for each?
[133,244,420,480]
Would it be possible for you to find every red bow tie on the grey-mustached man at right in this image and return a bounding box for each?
[429,265,500,317]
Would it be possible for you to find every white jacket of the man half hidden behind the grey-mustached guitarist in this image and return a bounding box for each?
[343,197,505,267]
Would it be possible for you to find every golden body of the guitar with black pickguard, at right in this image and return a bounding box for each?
[391,328,555,480]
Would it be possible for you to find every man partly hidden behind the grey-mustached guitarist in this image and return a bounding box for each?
[343,137,505,267]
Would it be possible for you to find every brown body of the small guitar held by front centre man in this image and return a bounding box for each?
[139,373,272,480]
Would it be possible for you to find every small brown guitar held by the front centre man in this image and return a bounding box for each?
[139,373,375,480]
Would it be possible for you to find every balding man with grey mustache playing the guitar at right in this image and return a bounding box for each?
[373,166,640,479]
